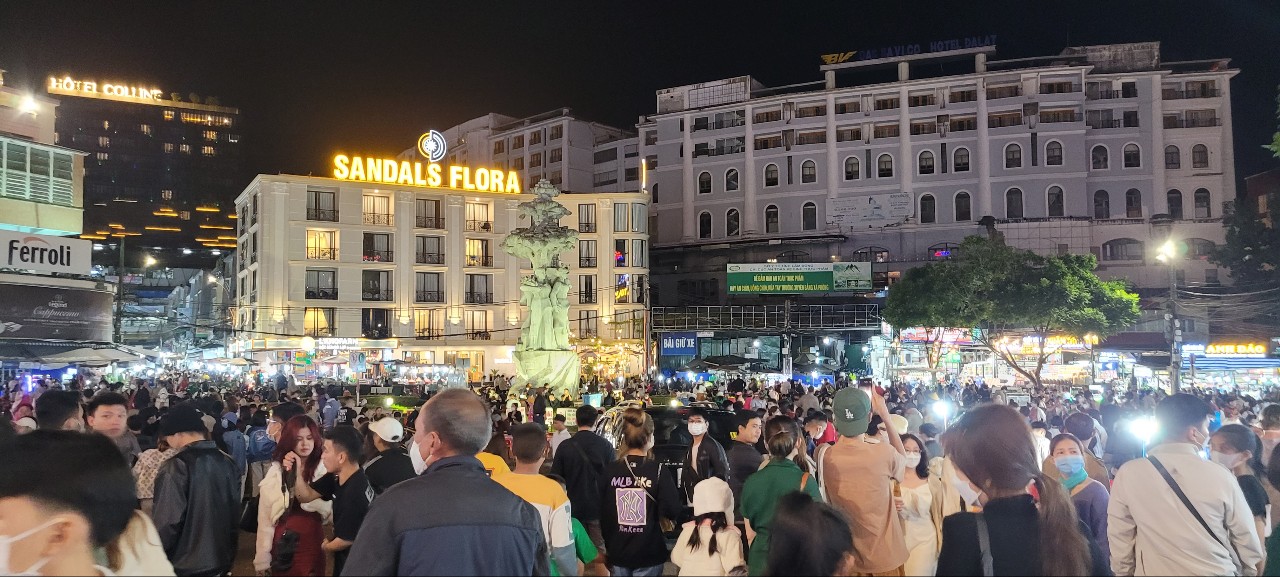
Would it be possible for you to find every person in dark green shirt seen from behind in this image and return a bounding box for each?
[741,416,822,576]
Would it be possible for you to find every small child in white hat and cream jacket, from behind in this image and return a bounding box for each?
[671,477,744,576]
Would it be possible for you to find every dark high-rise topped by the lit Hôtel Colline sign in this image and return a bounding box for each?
[45,75,244,259]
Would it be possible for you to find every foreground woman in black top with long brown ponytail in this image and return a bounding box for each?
[937,404,1111,576]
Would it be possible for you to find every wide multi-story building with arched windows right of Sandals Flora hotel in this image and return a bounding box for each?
[650,42,1238,306]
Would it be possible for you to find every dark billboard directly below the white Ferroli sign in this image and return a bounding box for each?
[0,284,114,342]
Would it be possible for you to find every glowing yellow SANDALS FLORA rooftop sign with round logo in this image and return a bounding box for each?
[333,130,521,194]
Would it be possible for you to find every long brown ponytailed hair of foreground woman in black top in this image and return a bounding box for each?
[947,404,1092,576]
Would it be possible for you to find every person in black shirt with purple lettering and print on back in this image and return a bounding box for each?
[599,408,685,577]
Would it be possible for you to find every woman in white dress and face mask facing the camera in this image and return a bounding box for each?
[895,434,942,576]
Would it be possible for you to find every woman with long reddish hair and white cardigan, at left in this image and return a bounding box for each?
[253,415,333,577]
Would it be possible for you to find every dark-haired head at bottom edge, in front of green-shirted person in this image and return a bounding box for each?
[764,491,854,577]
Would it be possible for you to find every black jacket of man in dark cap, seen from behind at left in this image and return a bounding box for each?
[151,440,241,576]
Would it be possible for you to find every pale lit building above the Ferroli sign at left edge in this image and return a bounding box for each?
[0,70,84,237]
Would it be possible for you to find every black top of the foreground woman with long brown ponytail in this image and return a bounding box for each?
[937,495,1111,577]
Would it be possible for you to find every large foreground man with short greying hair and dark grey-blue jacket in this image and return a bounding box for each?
[343,389,550,576]
